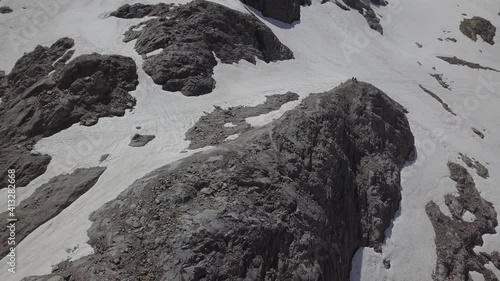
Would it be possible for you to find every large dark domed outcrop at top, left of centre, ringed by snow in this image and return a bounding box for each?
[115,0,293,96]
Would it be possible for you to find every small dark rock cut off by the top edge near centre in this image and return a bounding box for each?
[240,0,301,23]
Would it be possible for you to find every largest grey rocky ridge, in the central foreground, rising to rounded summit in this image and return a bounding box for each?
[23,82,414,281]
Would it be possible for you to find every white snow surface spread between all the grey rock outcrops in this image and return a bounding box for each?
[0,0,500,281]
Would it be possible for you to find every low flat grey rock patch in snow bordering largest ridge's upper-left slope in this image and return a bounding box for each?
[186,92,299,149]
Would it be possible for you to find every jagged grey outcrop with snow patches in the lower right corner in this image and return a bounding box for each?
[425,162,498,281]
